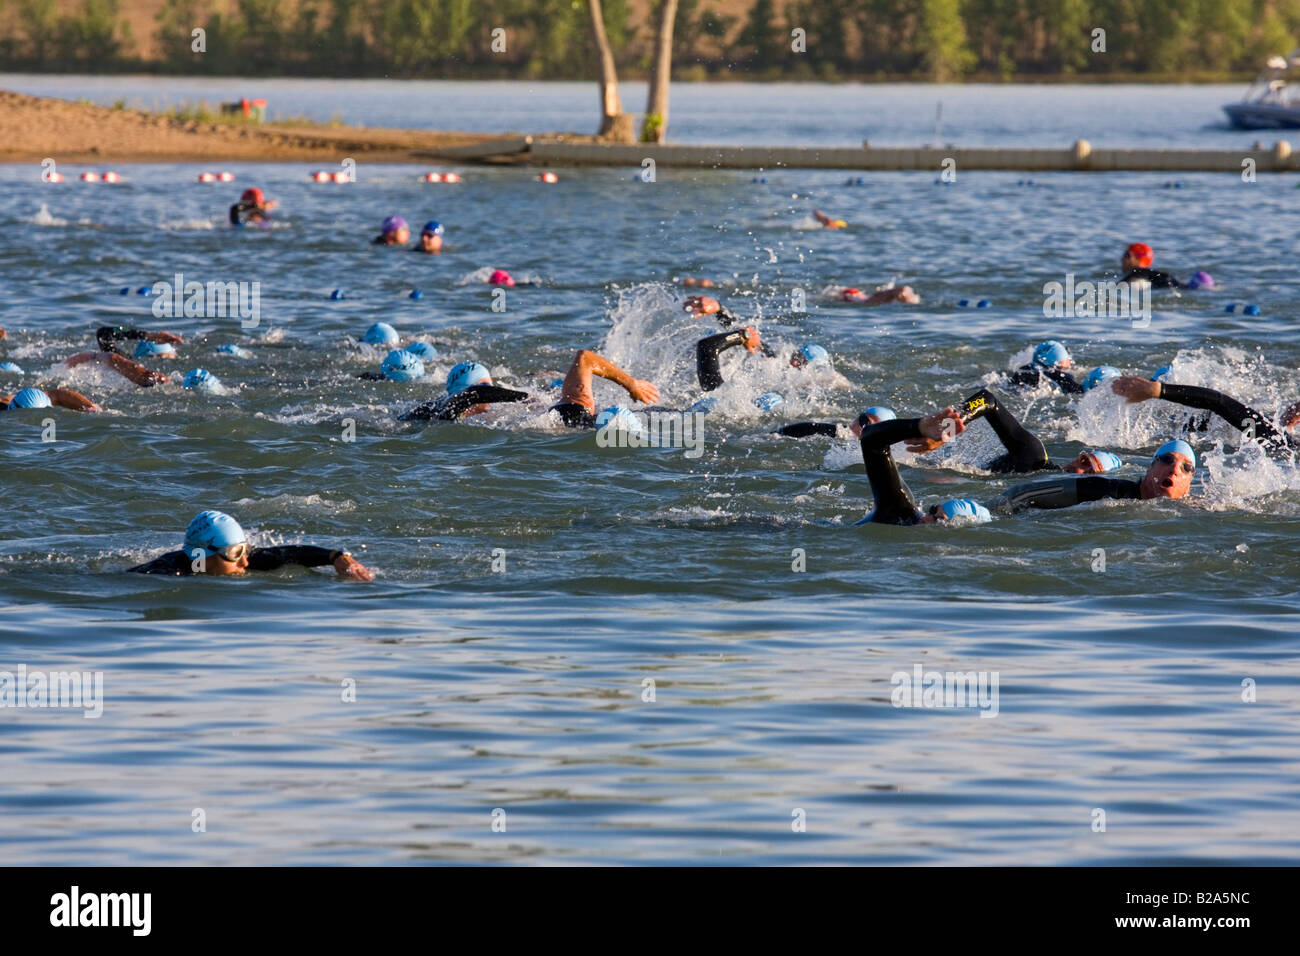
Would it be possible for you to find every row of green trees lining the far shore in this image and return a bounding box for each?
[0,0,1300,79]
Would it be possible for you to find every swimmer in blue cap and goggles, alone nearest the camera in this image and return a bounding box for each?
[129,511,374,581]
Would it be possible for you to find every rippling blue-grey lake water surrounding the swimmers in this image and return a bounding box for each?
[0,78,1300,865]
